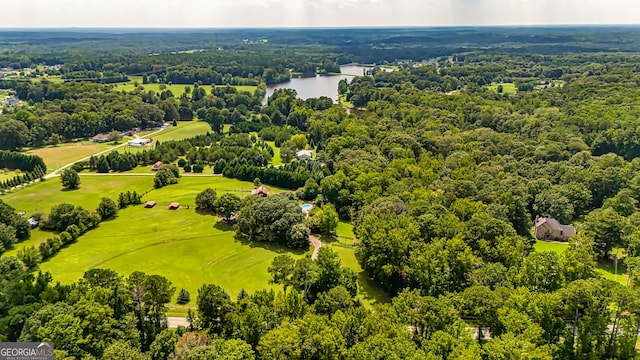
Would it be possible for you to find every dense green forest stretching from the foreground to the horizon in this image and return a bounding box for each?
[0,28,640,359]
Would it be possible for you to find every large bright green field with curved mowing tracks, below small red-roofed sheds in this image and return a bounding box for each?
[41,205,302,301]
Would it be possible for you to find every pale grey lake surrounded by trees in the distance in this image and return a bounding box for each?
[263,65,392,104]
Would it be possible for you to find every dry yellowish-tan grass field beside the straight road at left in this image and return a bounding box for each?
[27,141,115,170]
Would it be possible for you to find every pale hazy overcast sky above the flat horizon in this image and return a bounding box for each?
[0,0,640,28]
